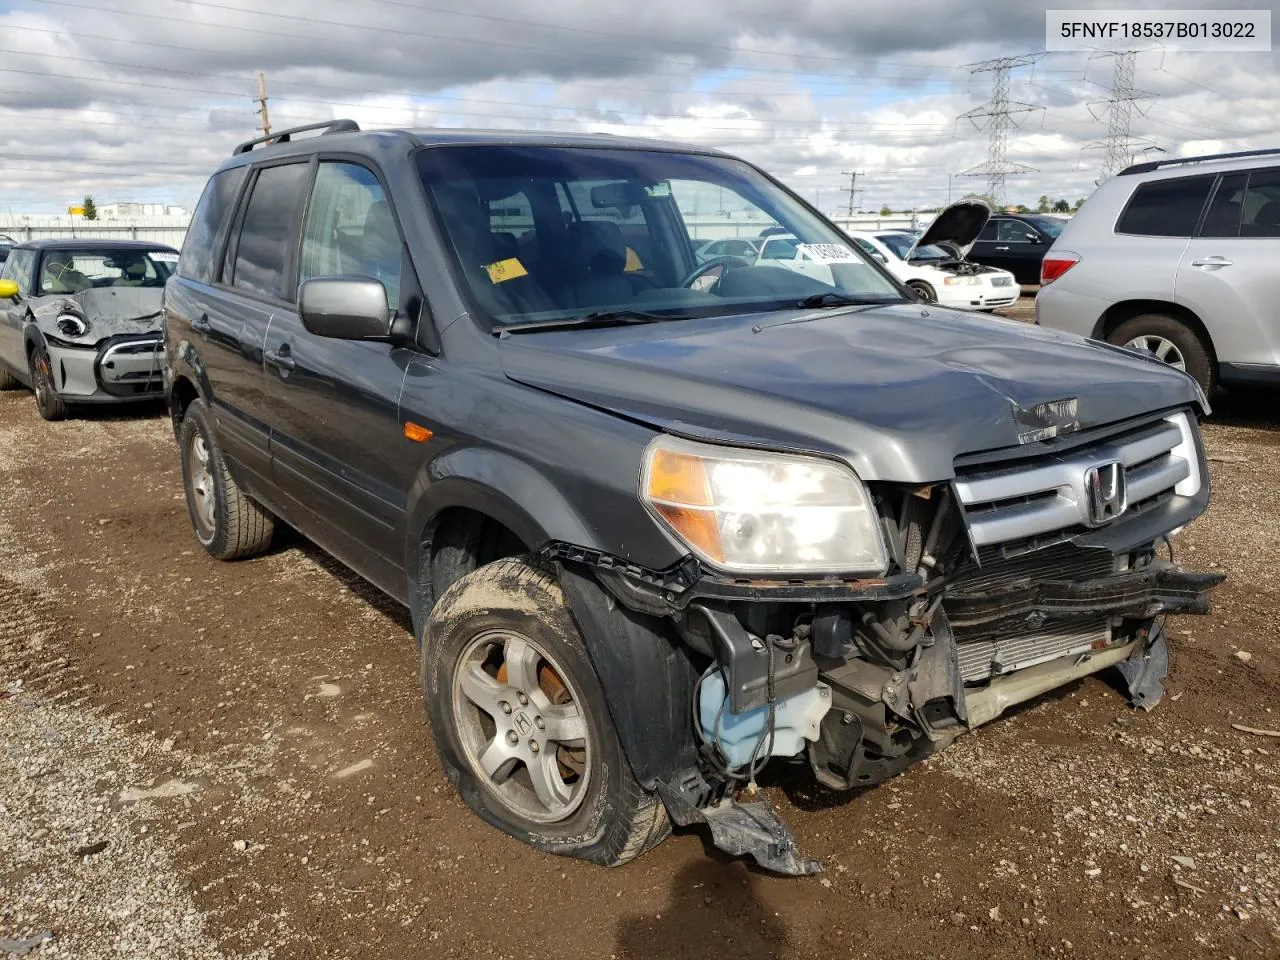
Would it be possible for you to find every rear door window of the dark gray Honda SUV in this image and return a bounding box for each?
[230,164,311,301]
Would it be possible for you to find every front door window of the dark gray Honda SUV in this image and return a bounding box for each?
[298,163,403,308]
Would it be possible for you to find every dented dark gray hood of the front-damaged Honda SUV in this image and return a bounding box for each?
[500,305,1199,483]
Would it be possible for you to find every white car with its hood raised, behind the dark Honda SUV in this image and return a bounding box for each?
[849,200,1023,310]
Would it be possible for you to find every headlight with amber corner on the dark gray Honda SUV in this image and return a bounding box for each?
[640,436,888,576]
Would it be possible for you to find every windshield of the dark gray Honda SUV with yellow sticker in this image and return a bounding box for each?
[419,146,904,326]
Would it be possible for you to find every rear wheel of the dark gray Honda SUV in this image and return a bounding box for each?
[178,399,275,561]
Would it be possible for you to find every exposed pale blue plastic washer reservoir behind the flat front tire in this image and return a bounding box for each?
[698,667,831,769]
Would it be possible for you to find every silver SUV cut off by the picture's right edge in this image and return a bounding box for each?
[1036,150,1280,393]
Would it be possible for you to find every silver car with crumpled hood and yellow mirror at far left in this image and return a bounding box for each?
[0,239,178,420]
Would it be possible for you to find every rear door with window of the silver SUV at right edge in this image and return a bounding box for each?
[1175,166,1280,379]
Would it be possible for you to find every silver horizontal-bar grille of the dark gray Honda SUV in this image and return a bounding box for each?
[956,413,1201,548]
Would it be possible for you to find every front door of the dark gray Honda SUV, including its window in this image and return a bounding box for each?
[266,159,421,596]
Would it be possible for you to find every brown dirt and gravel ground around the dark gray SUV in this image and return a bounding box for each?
[0,296,1280,960]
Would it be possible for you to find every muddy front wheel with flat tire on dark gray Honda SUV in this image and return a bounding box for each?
[421,557,671,867]
